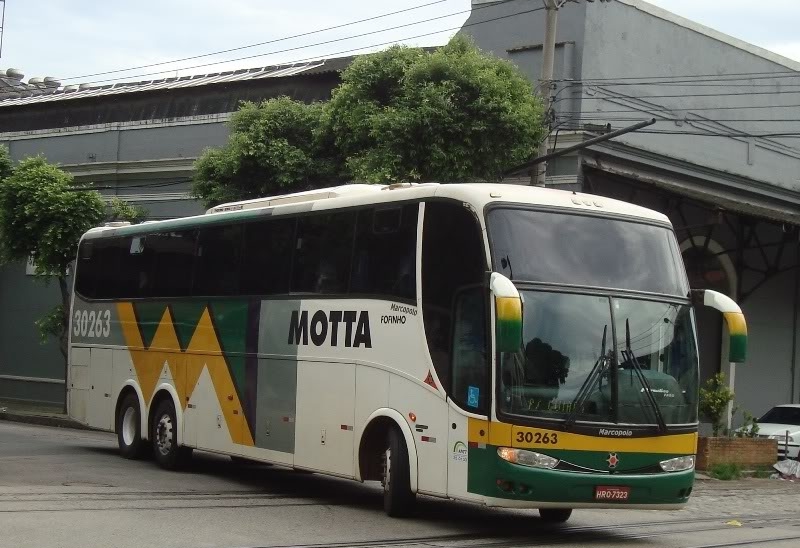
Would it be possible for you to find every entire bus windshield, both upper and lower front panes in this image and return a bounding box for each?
[488,208,698,428]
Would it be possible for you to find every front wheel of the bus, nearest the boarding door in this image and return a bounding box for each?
[381,427,416,517]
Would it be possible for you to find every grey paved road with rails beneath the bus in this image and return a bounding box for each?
[0,421,800,548]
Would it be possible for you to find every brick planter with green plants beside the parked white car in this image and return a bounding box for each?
[697,373,778,470]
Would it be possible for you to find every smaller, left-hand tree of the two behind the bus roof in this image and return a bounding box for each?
[192,97,341,207]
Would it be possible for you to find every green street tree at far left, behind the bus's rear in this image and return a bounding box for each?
[0,149,105,363]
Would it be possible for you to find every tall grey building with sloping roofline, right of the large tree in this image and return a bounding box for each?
[463,0,800,415]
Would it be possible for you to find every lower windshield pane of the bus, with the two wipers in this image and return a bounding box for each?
[499,290,698,425]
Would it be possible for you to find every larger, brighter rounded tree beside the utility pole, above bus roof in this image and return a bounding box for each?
[324,36,543,183]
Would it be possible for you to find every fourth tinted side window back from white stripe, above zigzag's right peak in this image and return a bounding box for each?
[194,225,242,295]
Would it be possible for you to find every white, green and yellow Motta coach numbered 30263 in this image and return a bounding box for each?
[67,183,746,522]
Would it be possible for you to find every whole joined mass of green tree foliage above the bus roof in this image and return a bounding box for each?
[193,37,543,206]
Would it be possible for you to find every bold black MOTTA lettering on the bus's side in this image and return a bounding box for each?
[289,310,372,348]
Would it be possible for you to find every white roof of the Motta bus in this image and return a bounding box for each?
[85,183,669,238]
